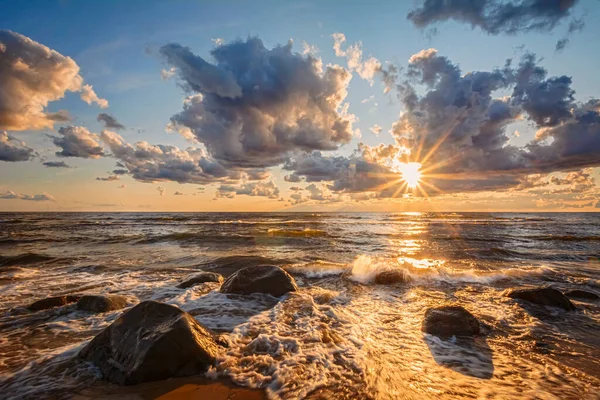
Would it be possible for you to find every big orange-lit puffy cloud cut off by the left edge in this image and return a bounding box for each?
[0,30,108,131]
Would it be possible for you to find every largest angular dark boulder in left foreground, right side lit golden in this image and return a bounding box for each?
[79,301,220,385]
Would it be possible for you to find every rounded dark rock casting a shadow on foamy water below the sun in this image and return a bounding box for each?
[421,306,480,337]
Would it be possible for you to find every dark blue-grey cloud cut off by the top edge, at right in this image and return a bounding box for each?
[407,0,578,35]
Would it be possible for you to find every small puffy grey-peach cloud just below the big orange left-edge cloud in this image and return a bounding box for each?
[48,126,105,158]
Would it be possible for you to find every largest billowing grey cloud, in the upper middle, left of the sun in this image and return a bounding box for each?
[160,37,353,173]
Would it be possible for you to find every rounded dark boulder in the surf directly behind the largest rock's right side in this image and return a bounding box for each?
[221,265,298,297]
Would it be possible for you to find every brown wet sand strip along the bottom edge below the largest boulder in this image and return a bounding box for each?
[72,377,267,400]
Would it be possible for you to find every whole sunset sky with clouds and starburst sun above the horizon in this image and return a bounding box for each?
[0,0,600,212]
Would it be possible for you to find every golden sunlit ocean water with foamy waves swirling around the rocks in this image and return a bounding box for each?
[0,213,600,399]
